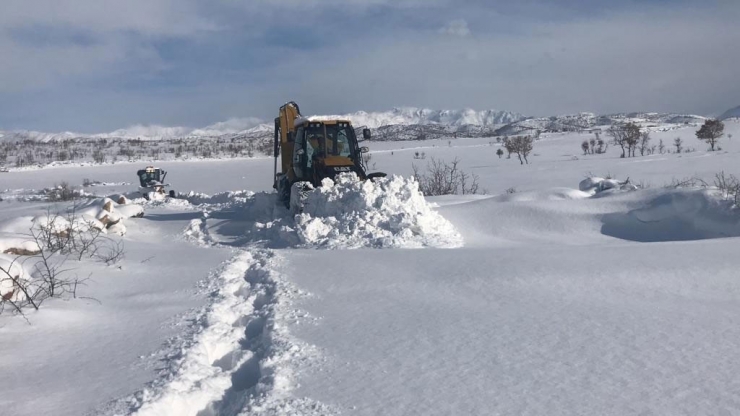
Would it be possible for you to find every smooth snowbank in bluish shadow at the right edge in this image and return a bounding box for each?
[601,190,740,242]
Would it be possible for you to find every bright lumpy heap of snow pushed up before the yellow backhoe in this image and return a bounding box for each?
[296,173,462,249]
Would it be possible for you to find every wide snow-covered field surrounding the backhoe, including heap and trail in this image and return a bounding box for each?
[0,120,740,416]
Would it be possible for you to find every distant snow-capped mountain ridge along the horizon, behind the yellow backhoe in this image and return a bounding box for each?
[0,107,716,142]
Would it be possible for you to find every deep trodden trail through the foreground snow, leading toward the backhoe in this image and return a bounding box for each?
[121,248,326,416]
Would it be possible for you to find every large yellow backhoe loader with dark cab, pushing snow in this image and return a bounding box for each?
[273,101,386,212]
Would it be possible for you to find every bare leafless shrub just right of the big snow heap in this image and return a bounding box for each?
[412,158,480,196]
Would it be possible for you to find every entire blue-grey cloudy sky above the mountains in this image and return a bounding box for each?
[0,0,740,132]
